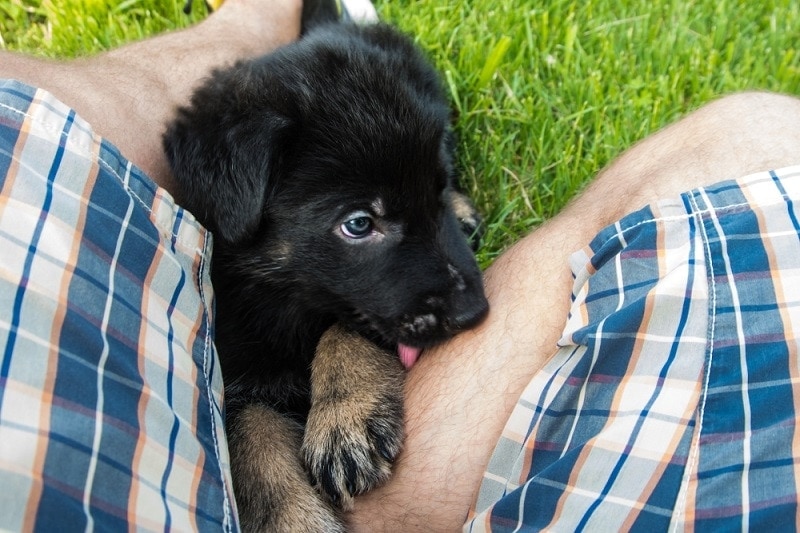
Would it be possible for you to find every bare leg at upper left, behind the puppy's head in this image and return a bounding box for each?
[0,0,302,194]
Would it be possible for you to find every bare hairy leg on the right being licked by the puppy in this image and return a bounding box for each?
[351,93,800,531]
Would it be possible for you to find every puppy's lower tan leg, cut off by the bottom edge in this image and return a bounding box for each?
[228,404,344,532]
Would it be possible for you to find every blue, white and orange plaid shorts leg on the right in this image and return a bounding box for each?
[465,167,800,531]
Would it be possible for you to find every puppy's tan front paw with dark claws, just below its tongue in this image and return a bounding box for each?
[302,326,405,509]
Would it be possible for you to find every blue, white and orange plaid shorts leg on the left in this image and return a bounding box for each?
[0,80,237,531]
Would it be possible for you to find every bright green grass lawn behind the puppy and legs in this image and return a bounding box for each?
[0,0,800,266]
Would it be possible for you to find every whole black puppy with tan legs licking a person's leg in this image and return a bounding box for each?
[164,16,488,531]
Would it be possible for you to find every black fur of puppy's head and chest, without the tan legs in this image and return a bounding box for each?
[164,18,488,524]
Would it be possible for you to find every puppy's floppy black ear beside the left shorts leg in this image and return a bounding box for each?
[164,102,289,243]
